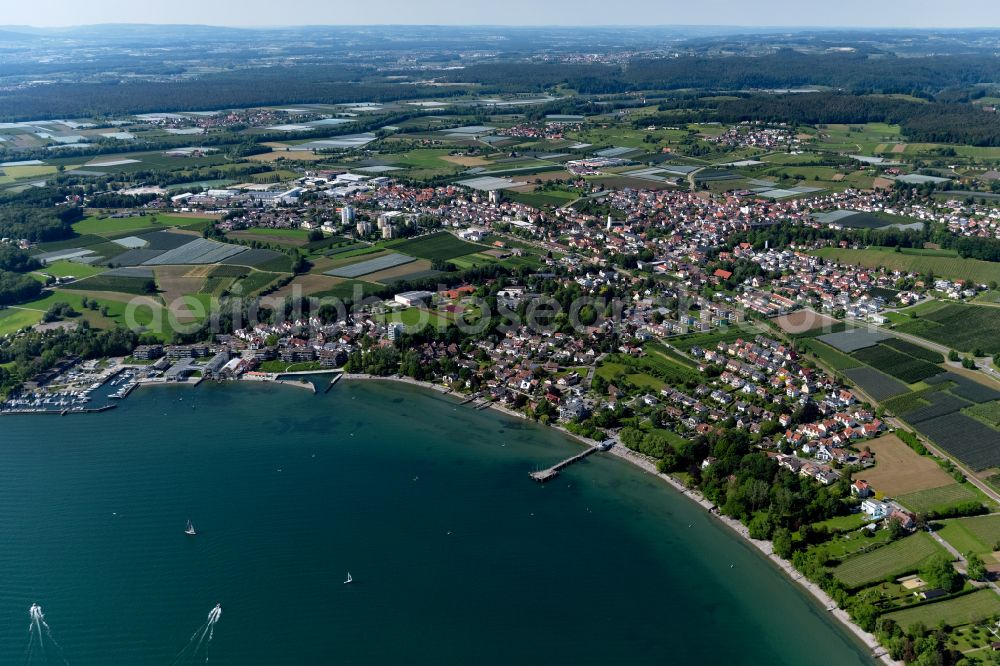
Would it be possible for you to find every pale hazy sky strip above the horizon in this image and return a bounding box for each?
[0,0,1000,28]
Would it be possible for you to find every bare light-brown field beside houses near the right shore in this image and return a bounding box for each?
[855,435,957,497]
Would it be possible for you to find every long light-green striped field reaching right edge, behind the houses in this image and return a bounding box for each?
[812,247,1000,284]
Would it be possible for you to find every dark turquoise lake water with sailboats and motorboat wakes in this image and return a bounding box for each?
[0,380,872,665]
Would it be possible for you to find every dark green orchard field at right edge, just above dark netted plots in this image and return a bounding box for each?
[896,304,1000,355]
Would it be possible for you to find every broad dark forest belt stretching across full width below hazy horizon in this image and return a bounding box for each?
[0,49,1000,122]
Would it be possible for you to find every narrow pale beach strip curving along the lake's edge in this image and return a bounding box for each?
[343,373,902,666]
